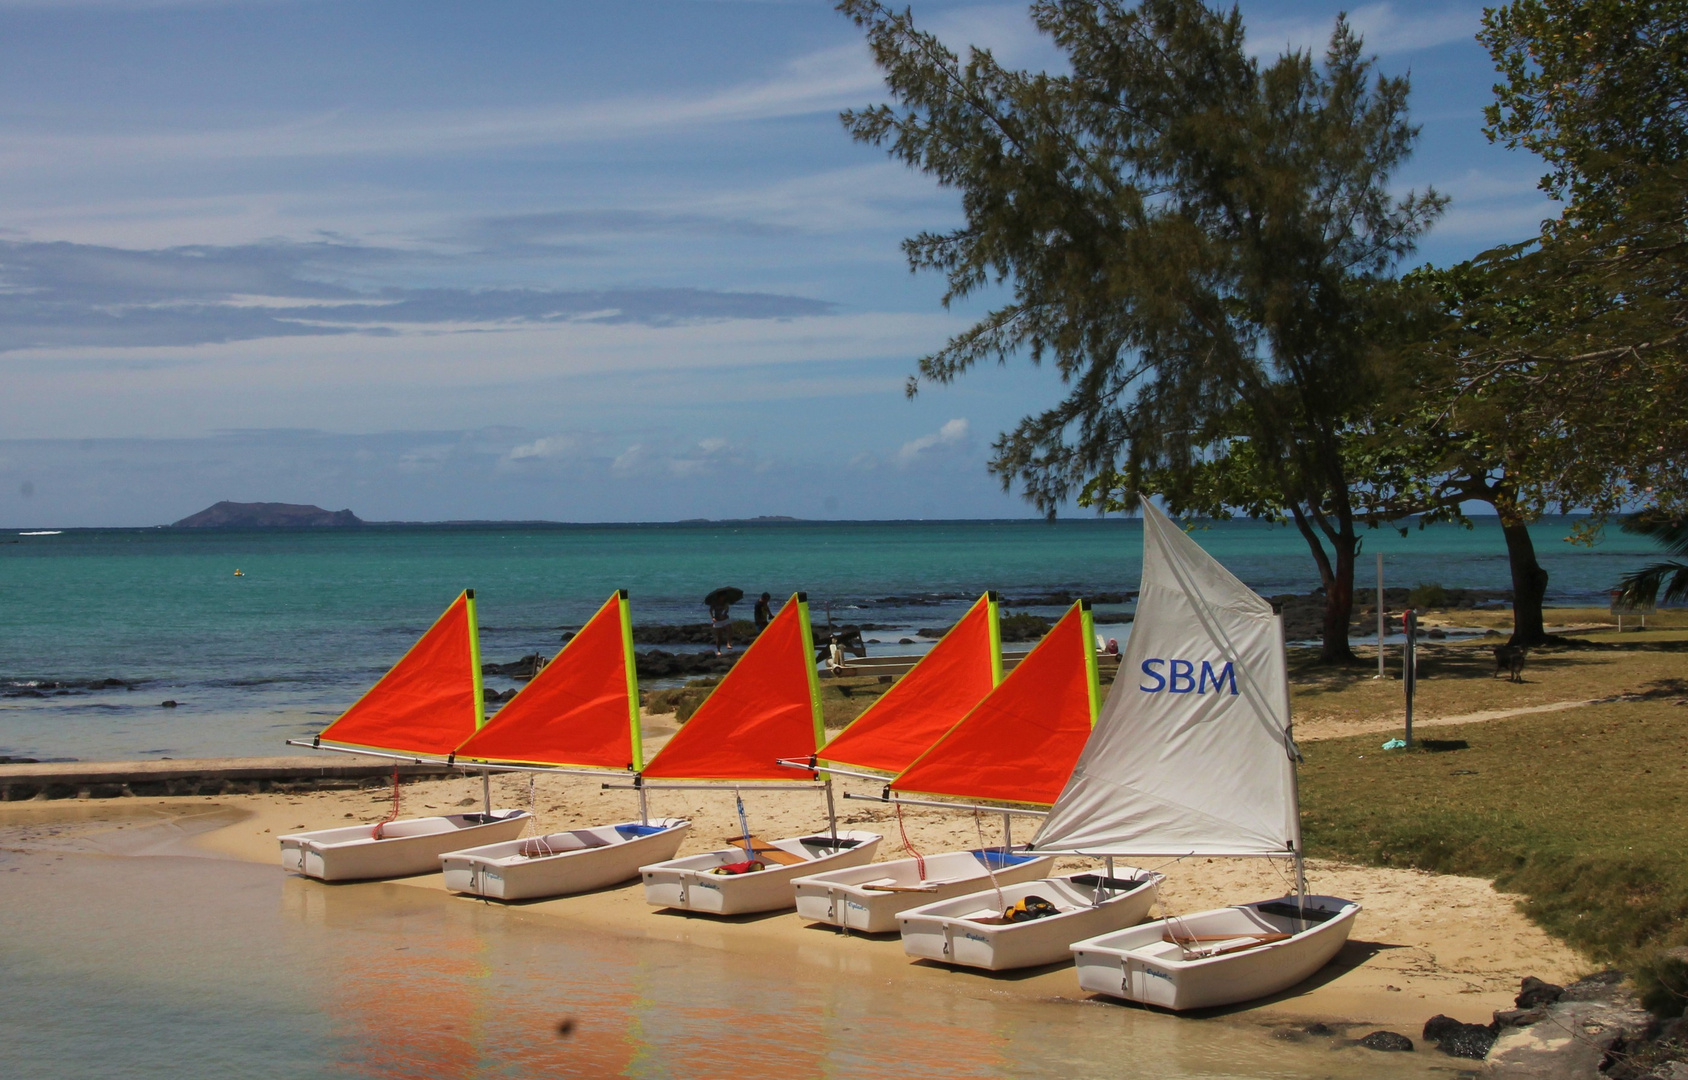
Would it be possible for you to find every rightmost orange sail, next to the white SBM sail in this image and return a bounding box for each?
[891,601,1101,805]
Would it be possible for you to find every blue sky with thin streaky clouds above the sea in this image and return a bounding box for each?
[0,0,1551,528]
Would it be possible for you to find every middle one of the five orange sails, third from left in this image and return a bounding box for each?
[645,592,822,780]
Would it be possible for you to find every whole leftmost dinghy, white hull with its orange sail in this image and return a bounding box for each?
[279,589,530,881]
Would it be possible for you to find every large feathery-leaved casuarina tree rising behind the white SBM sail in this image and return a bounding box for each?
[839,0,1443,660]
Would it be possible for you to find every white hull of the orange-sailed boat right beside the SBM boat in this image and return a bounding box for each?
[898,867,1161,972]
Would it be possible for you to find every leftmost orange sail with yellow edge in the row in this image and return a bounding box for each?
[321,589,486,756]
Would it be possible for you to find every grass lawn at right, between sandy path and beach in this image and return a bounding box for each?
[1301,695,1688,962]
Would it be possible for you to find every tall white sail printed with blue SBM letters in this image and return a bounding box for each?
[1033,503,1301,856]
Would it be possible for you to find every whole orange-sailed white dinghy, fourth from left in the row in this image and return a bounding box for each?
[792,592,1053,933]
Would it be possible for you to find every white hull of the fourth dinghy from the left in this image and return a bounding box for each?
[792,851,1055,933]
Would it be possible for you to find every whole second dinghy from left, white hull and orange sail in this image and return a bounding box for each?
[439,589,692,899]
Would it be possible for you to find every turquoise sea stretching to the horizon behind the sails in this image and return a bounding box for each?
[0,520,1654,759]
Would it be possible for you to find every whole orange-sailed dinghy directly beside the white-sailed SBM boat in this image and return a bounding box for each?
[890,601,1161,970]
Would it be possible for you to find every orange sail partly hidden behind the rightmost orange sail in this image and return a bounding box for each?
[820,592,1003,773]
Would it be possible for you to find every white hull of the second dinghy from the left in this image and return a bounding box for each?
[439,818,692,899]
